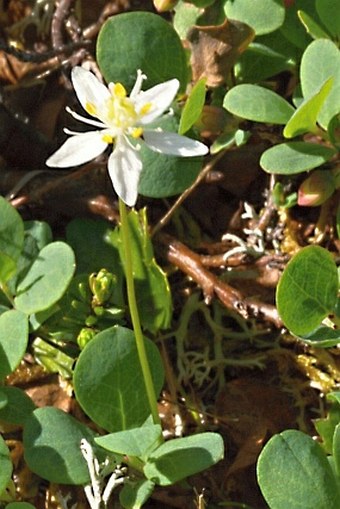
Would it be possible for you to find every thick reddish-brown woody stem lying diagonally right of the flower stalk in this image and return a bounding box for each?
[160,235,283,328]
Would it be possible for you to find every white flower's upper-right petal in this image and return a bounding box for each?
[134,79,179,125]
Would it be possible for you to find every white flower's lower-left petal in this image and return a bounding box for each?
[46,131,107,168]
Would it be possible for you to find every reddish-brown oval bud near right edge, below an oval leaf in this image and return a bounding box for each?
[298,170,335,207]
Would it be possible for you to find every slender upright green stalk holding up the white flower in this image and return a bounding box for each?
[119,199,161,424]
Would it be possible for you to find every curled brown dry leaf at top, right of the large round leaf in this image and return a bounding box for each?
[188,19,255,87]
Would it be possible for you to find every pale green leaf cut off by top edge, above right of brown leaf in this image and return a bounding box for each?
[224,0,285,35]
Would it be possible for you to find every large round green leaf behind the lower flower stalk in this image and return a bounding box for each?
[73,326,163,432]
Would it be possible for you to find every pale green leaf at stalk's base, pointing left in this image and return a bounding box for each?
[95,424,162,458]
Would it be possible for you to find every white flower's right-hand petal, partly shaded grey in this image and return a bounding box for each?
[143,131,209,157]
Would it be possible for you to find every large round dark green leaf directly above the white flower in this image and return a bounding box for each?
[97,12,187,90]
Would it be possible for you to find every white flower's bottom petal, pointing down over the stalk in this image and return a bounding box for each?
[108,137,143,207]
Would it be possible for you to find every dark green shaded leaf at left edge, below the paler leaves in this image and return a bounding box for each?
[0,387,35,426]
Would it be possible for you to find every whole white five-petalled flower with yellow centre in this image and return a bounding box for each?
[46,67,208,207]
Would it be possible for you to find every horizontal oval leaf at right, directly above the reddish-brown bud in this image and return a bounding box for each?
[260,141,336,175]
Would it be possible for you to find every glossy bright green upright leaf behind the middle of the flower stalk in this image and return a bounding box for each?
[111,208,172,333]
